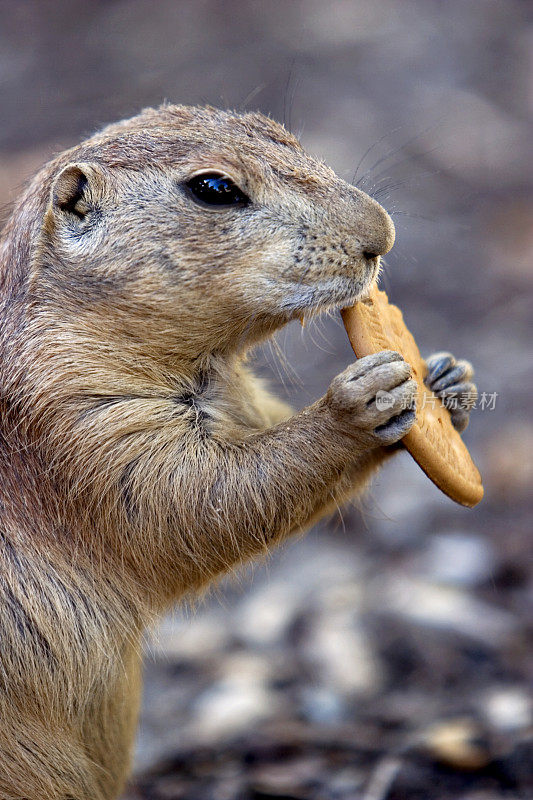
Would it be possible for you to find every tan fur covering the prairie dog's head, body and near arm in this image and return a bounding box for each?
[0,106,414,800]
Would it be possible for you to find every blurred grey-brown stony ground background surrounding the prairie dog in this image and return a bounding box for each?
[0,0,533,800]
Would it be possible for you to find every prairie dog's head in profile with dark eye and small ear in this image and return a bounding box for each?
[23,105,394,356]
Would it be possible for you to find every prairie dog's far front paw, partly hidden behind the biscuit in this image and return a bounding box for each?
[425,353,477,433]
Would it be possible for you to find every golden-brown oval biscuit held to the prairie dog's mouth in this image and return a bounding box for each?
[342,286,483,506]
